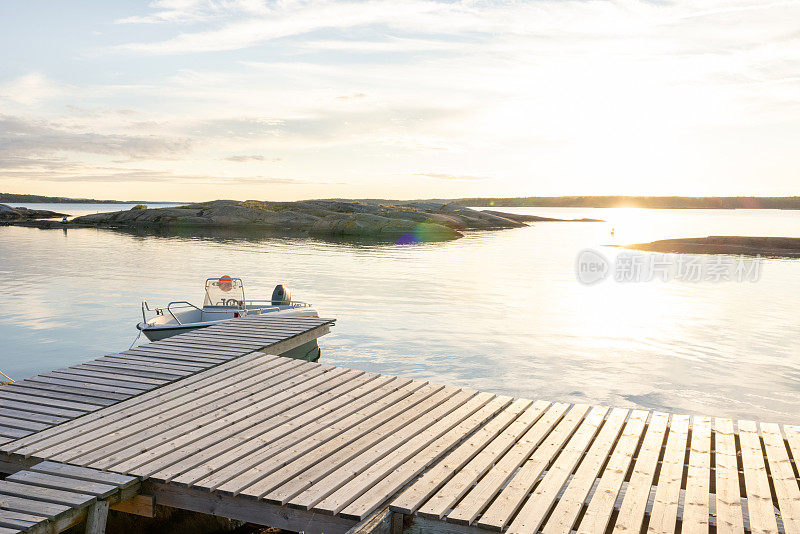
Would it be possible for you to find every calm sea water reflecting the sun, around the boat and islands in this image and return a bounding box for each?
[0,204,800,423]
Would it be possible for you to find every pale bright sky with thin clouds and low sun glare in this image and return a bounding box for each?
[0,0,800,201]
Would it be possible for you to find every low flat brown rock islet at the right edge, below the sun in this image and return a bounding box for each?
[625,235,800,258]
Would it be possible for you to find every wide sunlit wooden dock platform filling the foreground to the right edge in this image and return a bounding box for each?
[0,320,800,534]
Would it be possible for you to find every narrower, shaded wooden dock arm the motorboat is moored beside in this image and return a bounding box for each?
[0,316,334,444]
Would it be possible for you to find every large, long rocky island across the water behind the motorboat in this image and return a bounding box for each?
[48,199,526,241]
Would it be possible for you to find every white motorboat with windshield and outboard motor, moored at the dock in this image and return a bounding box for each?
[136,276,319,360]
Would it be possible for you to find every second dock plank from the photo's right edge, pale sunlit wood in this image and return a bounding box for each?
[761,423,800,534]
